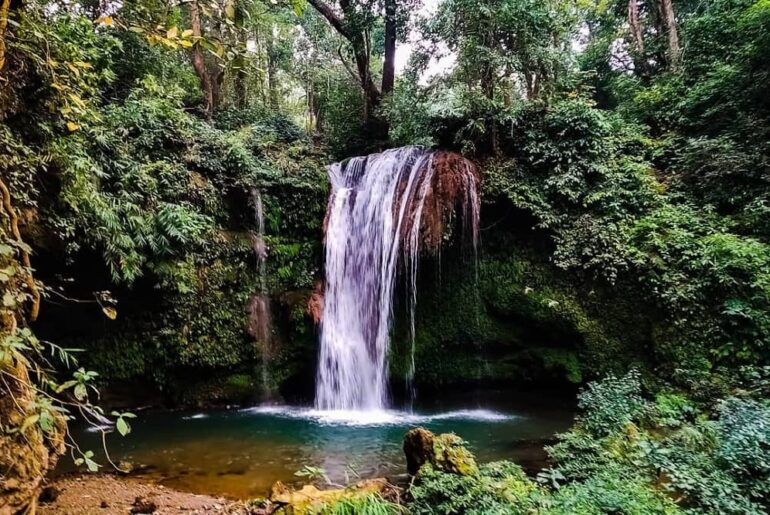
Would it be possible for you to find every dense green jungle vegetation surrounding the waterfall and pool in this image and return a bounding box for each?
[0,0,770,514]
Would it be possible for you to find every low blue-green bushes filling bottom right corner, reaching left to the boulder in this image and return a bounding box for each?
[409,372,770,514]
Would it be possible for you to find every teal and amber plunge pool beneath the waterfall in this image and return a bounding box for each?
[63,392,572,498]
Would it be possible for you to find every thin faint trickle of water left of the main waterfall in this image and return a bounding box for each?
[247,188,272,391]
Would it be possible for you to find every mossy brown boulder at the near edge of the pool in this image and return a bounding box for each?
[404,427,479,476]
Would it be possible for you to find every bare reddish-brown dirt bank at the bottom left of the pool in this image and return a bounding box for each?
[38,474,248,515]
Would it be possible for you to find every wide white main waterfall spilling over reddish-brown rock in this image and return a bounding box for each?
[316,147,479,410]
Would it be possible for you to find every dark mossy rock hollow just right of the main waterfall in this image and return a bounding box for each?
[391,242,649,385]
